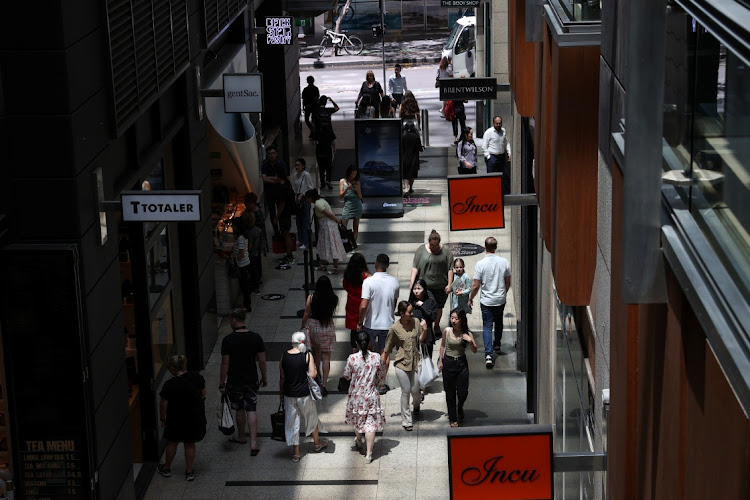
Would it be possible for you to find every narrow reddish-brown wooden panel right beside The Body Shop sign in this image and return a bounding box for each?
[510,0,537,117]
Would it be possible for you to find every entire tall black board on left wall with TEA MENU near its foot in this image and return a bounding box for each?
[0,245,95,500]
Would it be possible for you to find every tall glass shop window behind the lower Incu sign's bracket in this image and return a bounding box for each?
[554,300,594,500]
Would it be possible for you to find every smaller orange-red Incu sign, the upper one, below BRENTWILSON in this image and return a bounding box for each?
[448,174,505,231]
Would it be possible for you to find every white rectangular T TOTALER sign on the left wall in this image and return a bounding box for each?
[122,191,201,222]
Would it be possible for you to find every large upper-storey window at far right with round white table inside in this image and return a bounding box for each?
[663,8,750,295]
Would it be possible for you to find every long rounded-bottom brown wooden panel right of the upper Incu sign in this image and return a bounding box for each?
[550,40,599,305]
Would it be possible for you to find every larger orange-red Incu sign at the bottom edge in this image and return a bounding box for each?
[448,425,553,500]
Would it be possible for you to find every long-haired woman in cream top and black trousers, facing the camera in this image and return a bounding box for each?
[438,309,477,427]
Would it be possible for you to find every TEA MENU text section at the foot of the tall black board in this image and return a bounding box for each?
[20,440,83,500]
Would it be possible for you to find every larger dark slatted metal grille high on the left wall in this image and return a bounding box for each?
[107,0,190,135]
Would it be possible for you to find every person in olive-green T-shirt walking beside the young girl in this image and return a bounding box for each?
[409,229,453,344]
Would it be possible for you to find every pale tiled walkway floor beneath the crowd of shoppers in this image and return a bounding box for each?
[146,128,528,500]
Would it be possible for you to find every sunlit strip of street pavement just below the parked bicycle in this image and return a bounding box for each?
[299,35,447,69]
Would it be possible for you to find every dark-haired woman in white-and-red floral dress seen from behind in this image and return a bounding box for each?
[344,332,385,464]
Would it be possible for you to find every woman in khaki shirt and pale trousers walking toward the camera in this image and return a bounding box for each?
[384,300,427,432]
